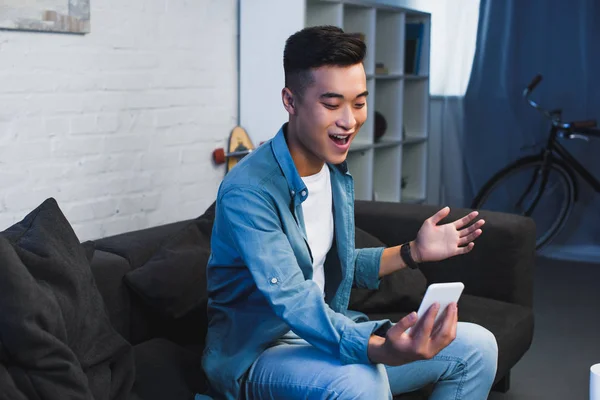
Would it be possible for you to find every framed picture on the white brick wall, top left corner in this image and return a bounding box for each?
[0,0,90,33]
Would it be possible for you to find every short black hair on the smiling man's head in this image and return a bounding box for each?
[283,25,367,98]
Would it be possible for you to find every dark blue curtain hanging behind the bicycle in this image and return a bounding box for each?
[461,0,600,261]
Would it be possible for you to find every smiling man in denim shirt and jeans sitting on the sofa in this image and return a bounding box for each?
[203,27,497,400]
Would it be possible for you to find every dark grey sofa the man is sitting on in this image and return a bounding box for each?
[86,201,535,400]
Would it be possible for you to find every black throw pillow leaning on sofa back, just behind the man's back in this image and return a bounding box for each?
[125,222,210,318]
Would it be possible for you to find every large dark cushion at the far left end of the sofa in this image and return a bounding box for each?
[0,199,134,400]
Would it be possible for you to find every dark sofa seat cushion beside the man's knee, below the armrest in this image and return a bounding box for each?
[368,294,533,382]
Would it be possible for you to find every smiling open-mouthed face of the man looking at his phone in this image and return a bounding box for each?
[288,63,368,175]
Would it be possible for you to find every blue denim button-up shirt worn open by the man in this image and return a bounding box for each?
[202,125,391,399]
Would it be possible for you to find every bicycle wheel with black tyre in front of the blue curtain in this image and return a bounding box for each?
[471,157,575,250]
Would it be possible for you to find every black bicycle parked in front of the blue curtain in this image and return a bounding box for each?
[471,75,600,251]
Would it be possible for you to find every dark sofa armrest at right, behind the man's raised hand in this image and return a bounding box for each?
[355,201,535,307]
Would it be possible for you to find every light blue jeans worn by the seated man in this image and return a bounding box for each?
[243,322,498,400]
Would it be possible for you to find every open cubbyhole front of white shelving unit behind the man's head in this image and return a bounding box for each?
[305,0,431,203]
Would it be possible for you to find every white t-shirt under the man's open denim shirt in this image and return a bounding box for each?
[302,164,333,295]
